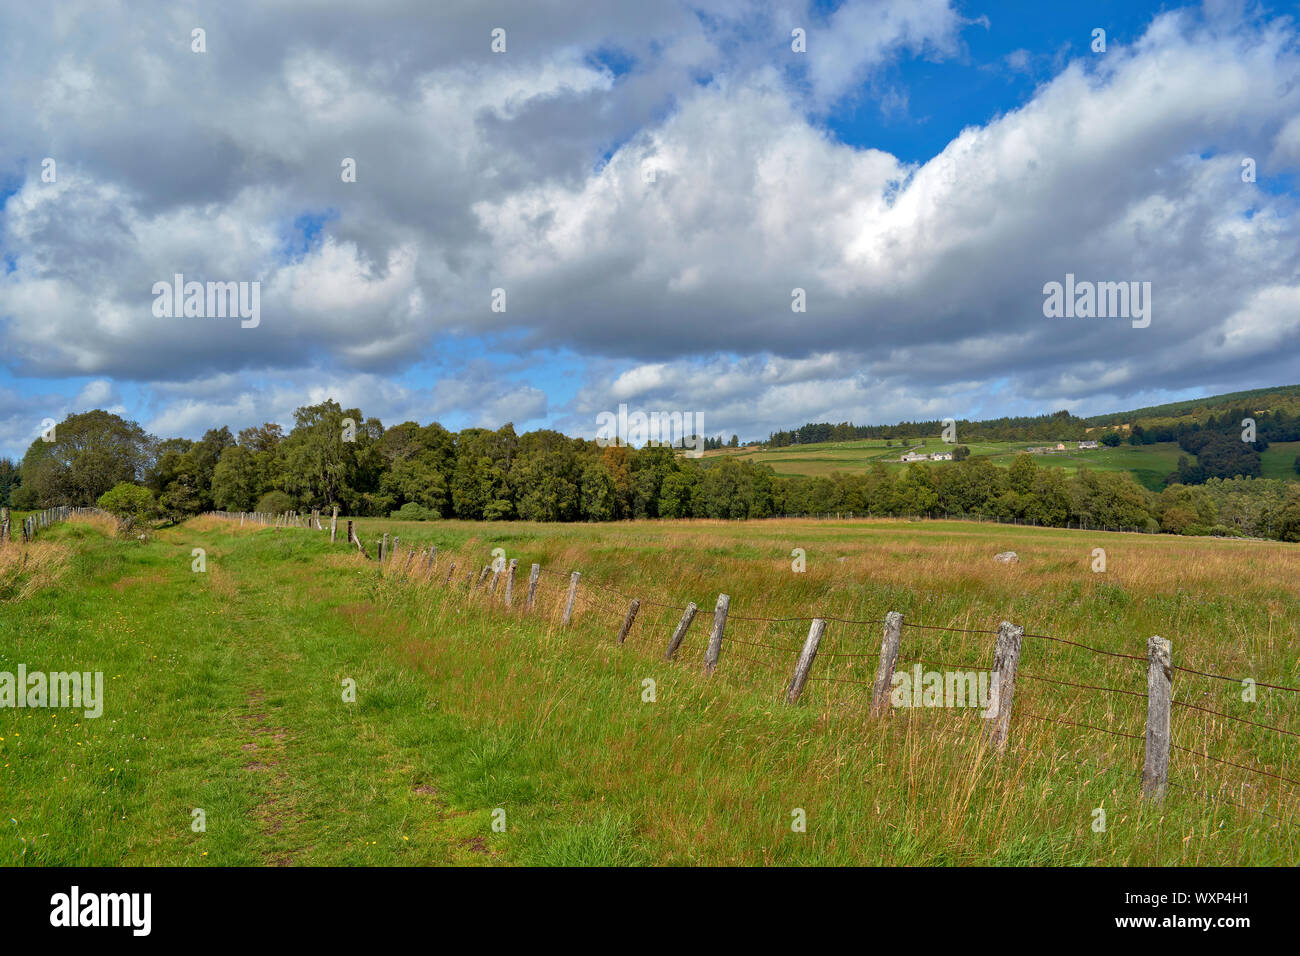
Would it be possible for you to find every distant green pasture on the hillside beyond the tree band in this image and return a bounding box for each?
[706,438,1190,490]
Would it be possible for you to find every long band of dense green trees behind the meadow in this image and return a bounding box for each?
[0,401,1300,541]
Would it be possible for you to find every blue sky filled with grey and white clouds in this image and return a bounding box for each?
[0,0,1300,457]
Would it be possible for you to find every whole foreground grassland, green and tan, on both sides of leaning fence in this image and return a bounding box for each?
[0,519,1300,865]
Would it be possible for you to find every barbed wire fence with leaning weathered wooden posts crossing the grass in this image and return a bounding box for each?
[197,512,1300,825]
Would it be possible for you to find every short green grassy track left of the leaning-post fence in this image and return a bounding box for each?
[0,525,498,865]
